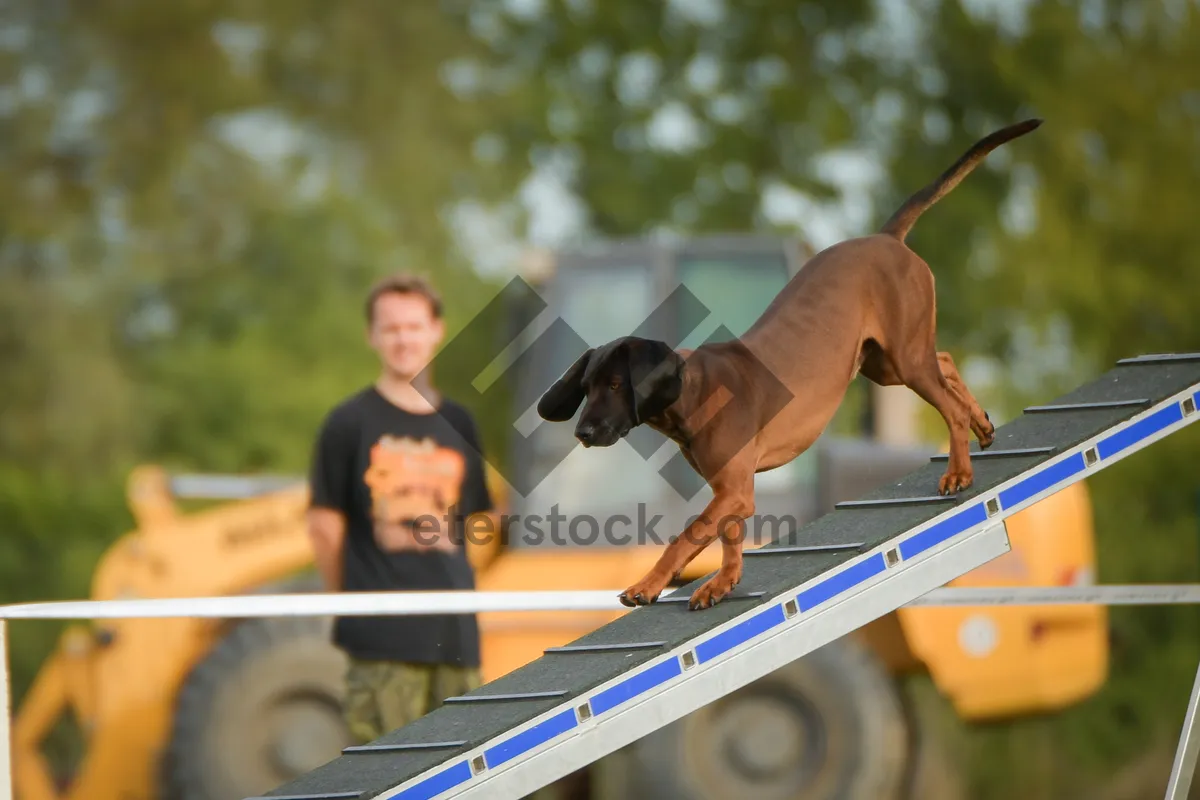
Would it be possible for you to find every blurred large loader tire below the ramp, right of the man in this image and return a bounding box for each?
[626,637,908,800]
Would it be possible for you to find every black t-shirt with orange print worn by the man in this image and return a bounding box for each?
[310,386,492,667]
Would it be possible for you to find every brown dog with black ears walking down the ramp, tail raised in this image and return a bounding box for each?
[538,120,1042,609]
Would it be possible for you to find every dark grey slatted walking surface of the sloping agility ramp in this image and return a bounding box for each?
[264,356,1200,799]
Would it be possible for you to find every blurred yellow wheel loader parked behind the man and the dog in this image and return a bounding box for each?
[13,232,1108,800]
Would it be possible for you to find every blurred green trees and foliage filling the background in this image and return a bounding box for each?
[0,0,1200,799]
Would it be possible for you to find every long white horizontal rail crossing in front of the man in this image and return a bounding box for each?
[0,584,1200,620]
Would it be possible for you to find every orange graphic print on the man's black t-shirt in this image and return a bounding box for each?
[362,435,466,551]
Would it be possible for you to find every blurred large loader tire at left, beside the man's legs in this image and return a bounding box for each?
[161,609,352,800]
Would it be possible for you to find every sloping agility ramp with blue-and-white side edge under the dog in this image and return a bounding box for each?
[226,354,1200,800]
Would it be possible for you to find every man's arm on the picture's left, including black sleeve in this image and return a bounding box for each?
[307,411,354,591]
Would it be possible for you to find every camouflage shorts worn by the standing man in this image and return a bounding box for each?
[344,658,482,745]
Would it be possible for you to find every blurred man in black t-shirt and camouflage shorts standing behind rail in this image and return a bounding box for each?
[310,275,492,744]
